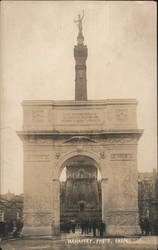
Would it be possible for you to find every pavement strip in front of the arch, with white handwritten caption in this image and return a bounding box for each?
[0,231,158,250]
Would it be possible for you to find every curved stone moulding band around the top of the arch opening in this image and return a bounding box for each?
[56,150,102,179]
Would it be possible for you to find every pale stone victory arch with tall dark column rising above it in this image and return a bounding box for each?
[18,15,142,236]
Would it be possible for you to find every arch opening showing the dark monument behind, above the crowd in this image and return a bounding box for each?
[59,154,102,232]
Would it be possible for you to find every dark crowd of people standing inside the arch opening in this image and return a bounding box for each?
[60,220,106,237]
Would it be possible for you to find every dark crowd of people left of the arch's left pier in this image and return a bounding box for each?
[0,219,23,239]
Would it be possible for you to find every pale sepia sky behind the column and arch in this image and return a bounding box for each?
[0,1,157,194]
